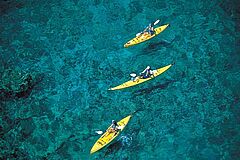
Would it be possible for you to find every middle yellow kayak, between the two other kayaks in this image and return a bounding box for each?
[108,64,173,90]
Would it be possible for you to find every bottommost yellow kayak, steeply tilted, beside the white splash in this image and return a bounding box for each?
[90,115,132,154]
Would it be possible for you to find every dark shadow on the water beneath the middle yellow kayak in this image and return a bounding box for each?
[133,80,176,97]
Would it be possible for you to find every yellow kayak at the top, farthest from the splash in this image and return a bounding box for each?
[124,24,169,48]
